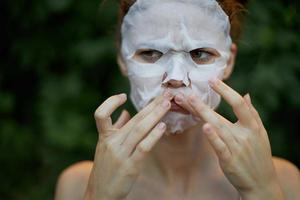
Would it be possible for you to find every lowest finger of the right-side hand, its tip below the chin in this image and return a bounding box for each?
[203,123,232,162]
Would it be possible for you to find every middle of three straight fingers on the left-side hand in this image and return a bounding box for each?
[123,100,171,155]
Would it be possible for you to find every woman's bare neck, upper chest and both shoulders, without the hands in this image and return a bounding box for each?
[56,89,300,200]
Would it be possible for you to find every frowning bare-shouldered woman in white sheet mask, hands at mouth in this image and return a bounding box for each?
[56,0,300,200]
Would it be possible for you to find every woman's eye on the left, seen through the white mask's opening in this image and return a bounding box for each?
[133,49,163,63]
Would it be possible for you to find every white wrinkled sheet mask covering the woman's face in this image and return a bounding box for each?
[121,0,232,133]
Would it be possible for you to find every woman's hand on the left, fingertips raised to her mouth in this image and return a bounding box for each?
[85,92,173,200]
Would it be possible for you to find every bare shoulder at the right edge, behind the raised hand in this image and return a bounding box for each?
[273,157,300,200]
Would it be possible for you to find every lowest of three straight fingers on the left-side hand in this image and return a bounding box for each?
[130,122,166,163]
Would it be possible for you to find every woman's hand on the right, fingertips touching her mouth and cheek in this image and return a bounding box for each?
[175,79,283,200]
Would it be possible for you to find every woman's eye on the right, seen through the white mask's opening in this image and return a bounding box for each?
[190,48,220,65]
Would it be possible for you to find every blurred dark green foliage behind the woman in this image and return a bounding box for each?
[0,0,300,200]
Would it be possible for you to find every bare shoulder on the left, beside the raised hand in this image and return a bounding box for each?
[55,161,93,200]
